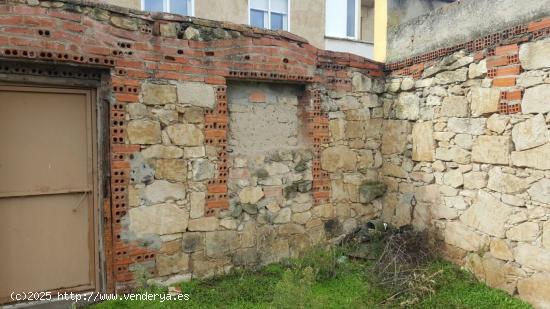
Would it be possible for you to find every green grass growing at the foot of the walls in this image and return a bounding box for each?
[93,250,532,309]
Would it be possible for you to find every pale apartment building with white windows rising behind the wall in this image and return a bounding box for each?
[95,0,387,61]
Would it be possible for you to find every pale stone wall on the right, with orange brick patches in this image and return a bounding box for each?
[381,31,550,308]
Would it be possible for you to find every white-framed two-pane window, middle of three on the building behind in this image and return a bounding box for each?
[249,0,290,31]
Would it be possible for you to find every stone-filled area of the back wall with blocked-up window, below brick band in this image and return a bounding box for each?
[122,77,384,284]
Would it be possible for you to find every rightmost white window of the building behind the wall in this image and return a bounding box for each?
[325,0,360,39]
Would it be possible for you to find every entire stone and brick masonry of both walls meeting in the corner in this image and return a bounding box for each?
[0,0,550,308]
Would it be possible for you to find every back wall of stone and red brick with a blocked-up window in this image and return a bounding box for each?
[0,0,384,291]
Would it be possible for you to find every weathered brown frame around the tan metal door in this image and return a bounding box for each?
[0,77,104,304]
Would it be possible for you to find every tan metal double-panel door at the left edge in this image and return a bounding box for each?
[0,85,97,303]
